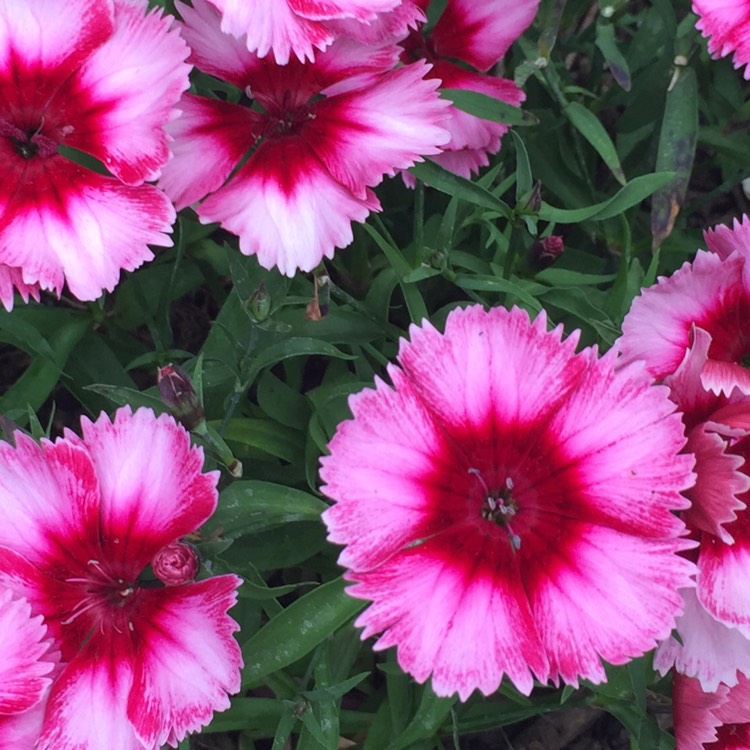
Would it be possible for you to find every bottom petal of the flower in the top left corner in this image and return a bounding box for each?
[0,156,175,300]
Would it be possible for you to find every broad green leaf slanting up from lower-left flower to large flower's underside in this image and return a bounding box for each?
[242,578,366,688]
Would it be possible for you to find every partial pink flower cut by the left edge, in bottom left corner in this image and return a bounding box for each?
[0,586,59,750]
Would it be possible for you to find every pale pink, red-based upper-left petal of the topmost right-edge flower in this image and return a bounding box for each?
[616,251,750,380]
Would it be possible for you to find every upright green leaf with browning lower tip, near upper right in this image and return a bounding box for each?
[651,68,698,249]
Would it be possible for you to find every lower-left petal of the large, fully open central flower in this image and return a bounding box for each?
[347,527,549,700]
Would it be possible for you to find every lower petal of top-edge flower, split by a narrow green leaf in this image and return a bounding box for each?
[430,61,526,154]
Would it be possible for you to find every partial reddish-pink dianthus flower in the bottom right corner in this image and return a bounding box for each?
[672,674,750,750]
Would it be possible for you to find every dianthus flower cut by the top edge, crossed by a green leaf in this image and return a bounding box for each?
[403,0,539,182]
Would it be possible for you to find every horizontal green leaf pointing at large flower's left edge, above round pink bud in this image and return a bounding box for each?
[202,480,328,539]
